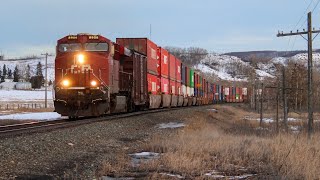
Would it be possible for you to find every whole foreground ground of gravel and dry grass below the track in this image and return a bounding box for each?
[0,104,320,179]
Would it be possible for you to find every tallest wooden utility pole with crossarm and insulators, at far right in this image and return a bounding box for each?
[277,12,320,138]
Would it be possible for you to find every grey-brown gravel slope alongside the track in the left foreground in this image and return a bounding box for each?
[0,106,212,179]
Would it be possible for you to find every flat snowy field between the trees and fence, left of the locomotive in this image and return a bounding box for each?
[0,90,52,103]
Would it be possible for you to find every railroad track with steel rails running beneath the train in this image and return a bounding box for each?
[0,106,205,137]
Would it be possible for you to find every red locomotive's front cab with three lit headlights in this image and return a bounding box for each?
[54,34,113,118]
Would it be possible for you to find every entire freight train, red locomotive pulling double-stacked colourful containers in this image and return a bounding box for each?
[54,34,247,119]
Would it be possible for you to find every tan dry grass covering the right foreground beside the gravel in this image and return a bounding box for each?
[99,106,320,179]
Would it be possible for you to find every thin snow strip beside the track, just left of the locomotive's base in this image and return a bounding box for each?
[0,112,61,121]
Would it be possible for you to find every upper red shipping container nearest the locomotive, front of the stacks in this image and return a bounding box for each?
[116,38,159,75]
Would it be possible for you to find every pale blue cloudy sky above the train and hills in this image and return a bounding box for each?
[0,0,320,57]
